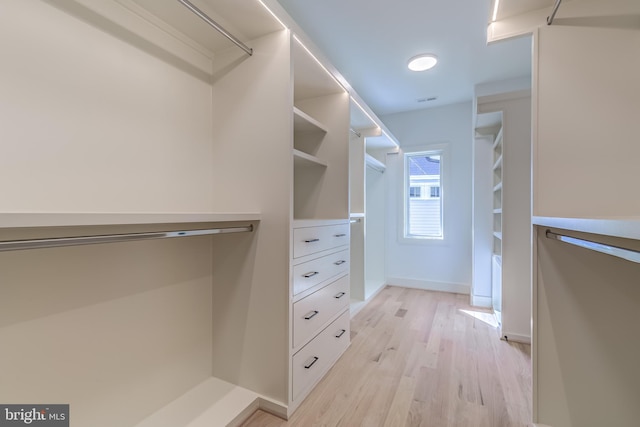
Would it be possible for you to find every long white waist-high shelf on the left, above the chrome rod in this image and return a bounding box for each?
[0,212,260,229]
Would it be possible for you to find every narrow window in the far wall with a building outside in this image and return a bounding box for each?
[404,150,443,239]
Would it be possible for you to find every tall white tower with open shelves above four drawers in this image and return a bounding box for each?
[289,36,350,413]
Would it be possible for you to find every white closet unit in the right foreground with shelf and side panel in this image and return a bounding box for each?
[533,11,640,427]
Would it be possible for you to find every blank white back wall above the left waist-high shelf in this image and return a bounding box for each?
[0,2,213,212]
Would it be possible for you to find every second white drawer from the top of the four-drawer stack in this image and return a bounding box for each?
[293,250,349,295]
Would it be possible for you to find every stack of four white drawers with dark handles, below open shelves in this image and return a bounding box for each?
[291,220,350,408]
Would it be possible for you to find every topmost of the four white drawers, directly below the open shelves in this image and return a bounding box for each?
[293,223,350,258]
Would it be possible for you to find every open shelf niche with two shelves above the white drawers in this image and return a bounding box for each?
[291,37,349,219]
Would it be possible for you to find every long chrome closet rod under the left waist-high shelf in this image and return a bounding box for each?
[0,225,253,252]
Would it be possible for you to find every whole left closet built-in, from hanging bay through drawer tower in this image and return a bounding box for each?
[0,0,349,427]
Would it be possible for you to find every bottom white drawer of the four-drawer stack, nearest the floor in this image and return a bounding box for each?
[291,310,350,400]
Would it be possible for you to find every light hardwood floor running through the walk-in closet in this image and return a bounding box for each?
[243,287,531,427]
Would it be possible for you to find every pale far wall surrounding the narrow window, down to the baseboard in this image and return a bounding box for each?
[382,102,472,293]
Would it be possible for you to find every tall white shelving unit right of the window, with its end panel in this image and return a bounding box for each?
[474,87,531,343]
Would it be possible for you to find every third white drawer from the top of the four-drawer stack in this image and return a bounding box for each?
[293,275,349,348]
